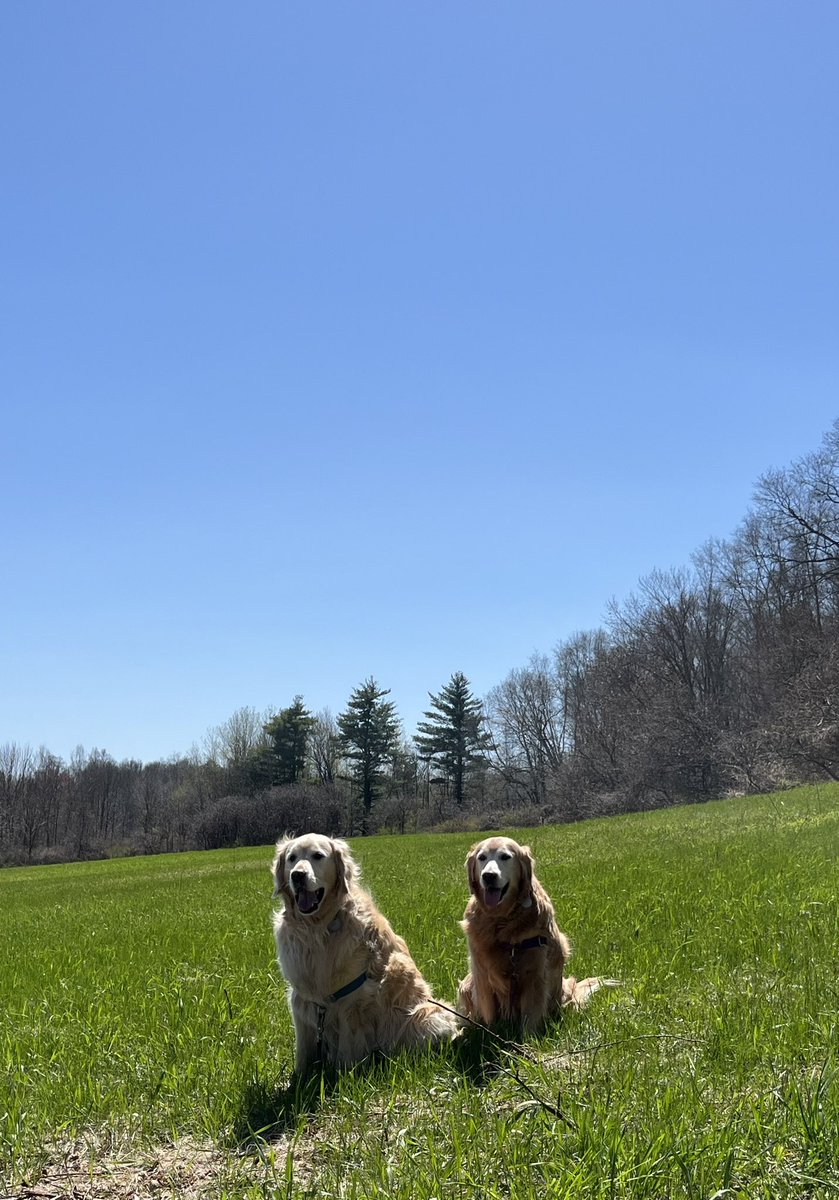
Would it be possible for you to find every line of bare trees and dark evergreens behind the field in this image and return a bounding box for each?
[0,421,839,863]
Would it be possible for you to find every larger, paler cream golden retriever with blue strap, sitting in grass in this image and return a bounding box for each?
[272,834,459,1073]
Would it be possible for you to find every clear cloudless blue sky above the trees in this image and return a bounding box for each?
[0,0,839,761]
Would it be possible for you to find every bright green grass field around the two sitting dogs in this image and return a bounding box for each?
[0,786,839,1200]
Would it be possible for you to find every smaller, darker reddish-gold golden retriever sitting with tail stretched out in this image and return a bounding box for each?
[459,838,616,1031]
